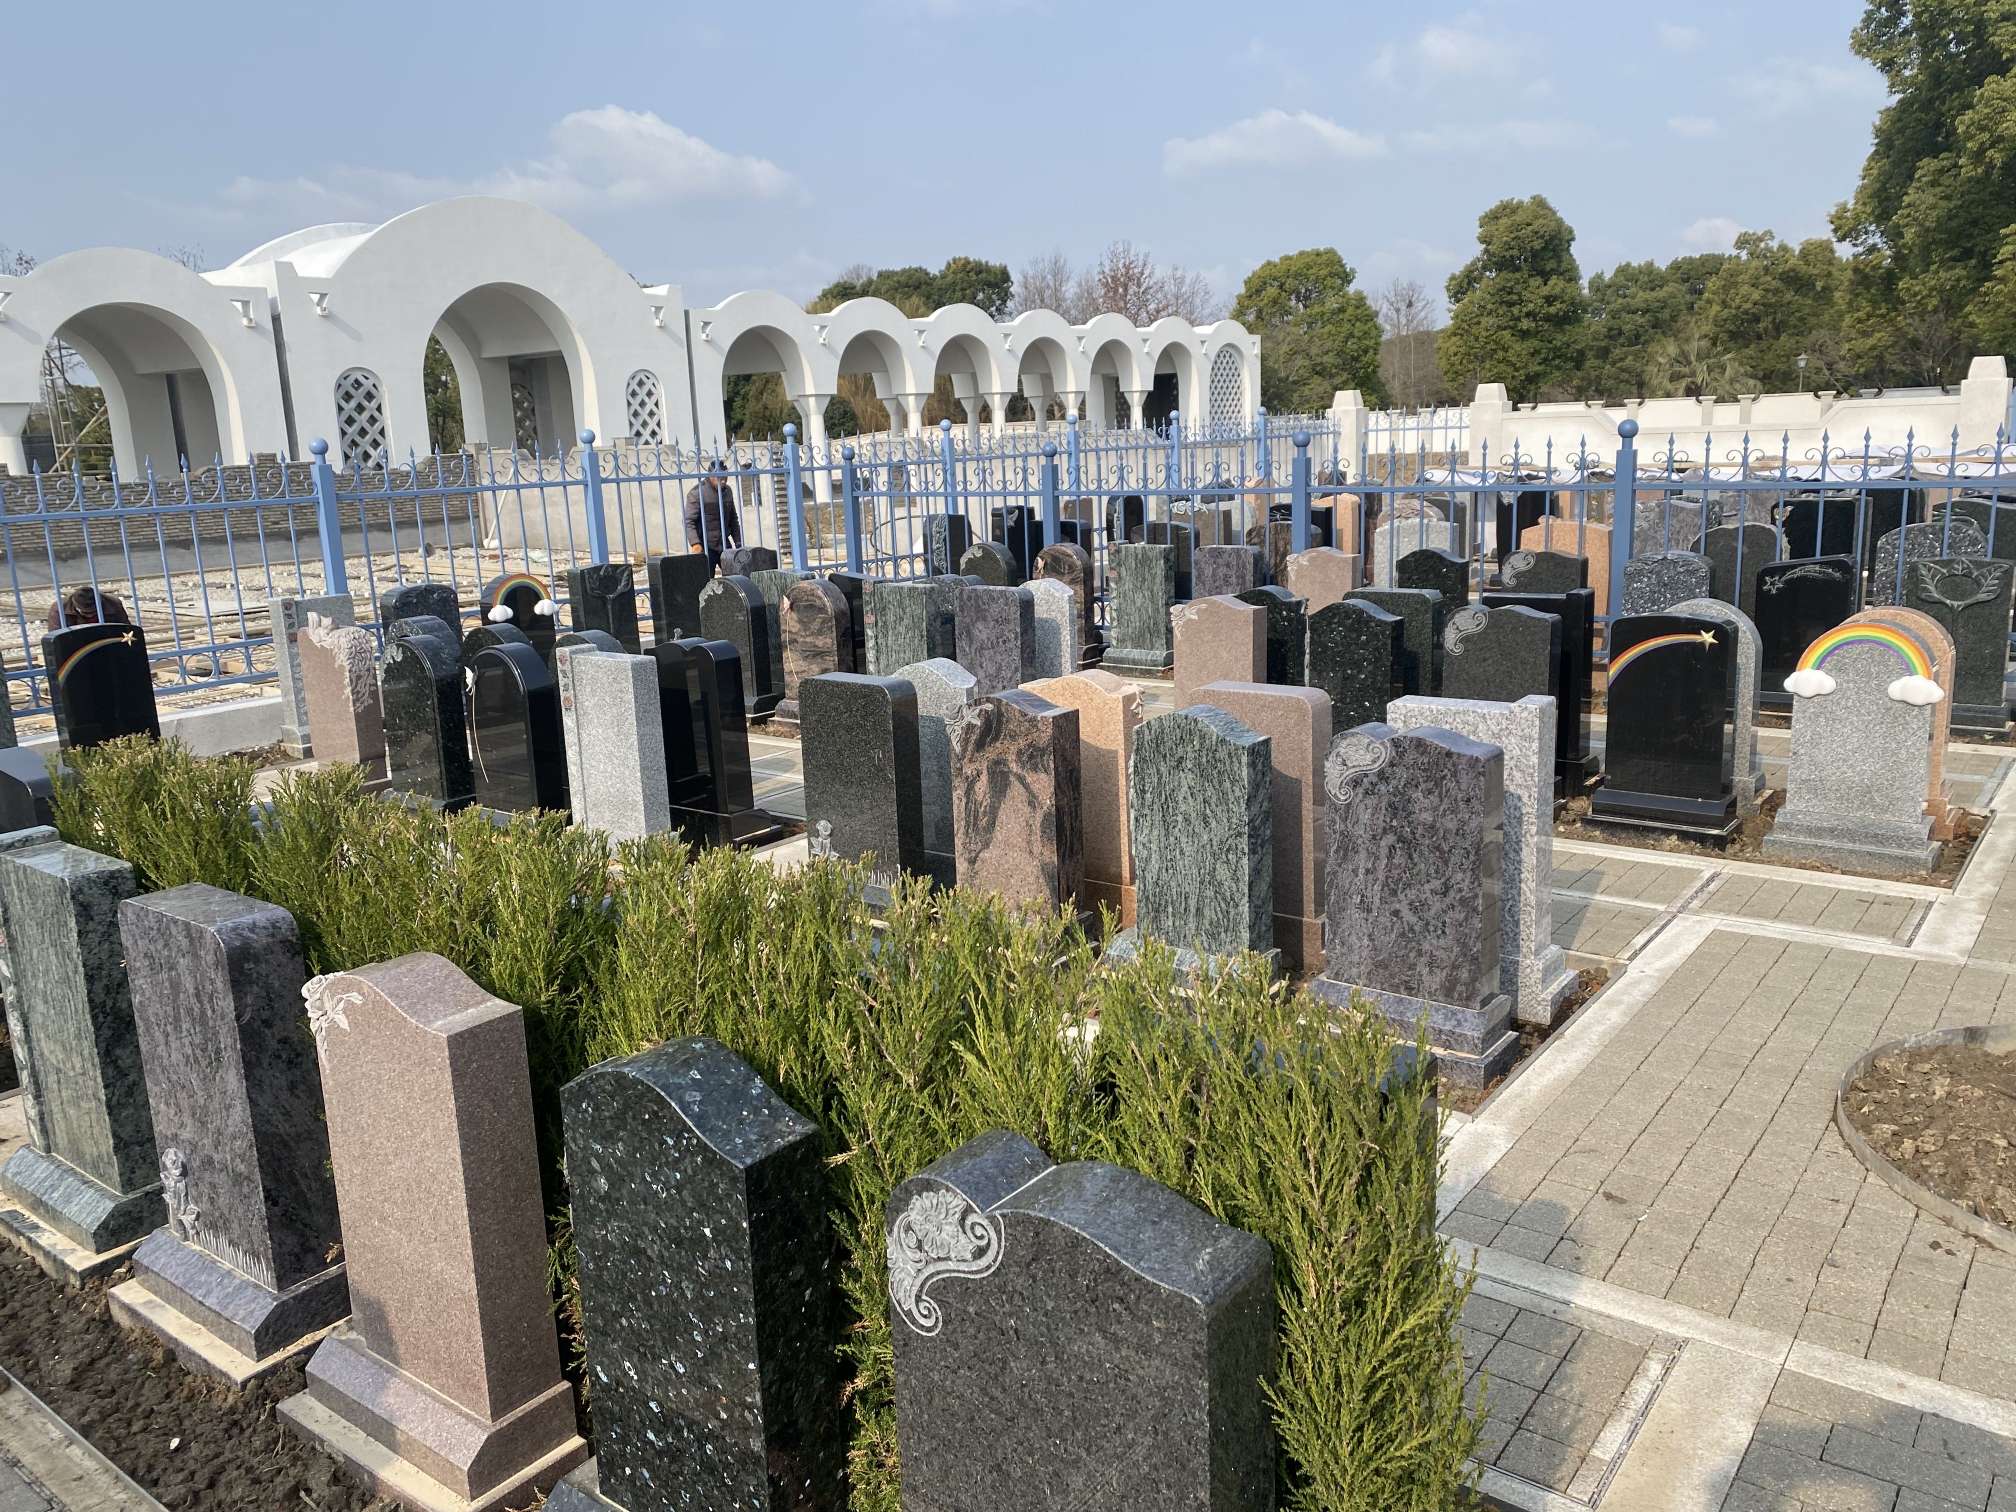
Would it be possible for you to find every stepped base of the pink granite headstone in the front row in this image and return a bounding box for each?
[280,1325,589,1508]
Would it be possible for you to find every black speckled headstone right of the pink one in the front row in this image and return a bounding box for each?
[546,1038,849,1512]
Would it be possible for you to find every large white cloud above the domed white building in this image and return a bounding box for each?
[222,105,796,220]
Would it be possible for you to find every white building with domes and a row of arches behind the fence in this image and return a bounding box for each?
[0,198,1260,472]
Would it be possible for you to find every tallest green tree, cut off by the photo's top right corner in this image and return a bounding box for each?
[1835,0,2016,383]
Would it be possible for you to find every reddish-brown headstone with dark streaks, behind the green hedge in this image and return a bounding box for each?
[952,689,1085,909]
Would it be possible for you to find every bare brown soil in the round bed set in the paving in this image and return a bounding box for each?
[1845,1044,2016,1230]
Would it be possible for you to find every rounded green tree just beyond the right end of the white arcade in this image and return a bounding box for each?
[1232,246,1385,413]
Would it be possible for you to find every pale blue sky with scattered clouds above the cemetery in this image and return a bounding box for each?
[0,0,1883,314]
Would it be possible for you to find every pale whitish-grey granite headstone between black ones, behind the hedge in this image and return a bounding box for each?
[566,653,671,841]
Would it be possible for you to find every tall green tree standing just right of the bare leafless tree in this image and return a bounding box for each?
[1439,194,1585,401]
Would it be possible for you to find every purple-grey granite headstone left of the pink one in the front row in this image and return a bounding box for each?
[113,895,348,1361]
